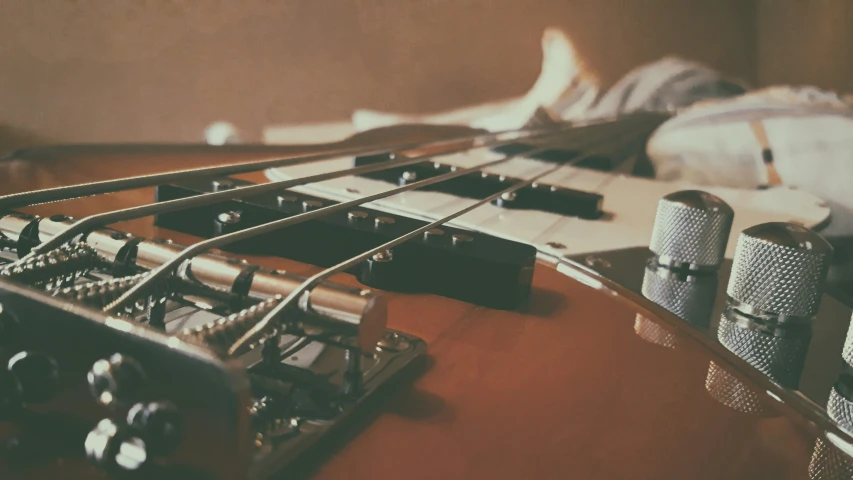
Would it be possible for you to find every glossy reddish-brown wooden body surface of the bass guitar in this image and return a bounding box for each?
[0,128,844,480]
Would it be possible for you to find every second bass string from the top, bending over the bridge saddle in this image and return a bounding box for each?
[28,126,584,261]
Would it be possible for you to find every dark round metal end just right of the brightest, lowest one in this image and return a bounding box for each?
[127,402,181,455]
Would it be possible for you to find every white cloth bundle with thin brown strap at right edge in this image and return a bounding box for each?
[646,87,853,277]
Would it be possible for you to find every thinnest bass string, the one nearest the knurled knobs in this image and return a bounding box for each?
[228,124,652,356]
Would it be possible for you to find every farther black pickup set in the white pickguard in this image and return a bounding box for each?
[355,155,604,220]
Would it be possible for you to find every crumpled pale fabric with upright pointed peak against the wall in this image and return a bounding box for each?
[352,28,748,131]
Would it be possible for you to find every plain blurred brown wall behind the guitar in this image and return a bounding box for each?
[0,0,853,146]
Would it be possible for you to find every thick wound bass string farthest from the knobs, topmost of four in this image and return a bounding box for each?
[0,115,640,212]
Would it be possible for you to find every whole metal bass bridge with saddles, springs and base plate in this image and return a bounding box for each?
[0,213,426,479]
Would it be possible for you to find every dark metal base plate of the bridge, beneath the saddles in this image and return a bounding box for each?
[0,266,427,480]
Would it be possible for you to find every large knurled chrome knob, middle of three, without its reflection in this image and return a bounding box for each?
[726,222,832,318]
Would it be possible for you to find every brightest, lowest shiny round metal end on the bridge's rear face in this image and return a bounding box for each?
[84,418,148,473]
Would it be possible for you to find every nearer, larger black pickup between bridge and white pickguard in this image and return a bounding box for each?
[155,178,536,309]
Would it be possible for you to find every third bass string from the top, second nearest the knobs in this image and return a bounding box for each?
[104,118,652,312]
